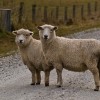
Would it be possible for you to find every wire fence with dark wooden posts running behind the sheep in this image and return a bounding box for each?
[0,0,100,31]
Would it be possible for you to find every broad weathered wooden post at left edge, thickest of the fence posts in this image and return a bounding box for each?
[0,9,11,32]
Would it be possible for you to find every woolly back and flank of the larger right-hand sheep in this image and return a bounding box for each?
[50,37,100,71]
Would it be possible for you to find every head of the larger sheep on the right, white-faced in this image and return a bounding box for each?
[37,24,57,40]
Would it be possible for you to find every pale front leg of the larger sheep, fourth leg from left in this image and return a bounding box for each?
[55,64,63,87]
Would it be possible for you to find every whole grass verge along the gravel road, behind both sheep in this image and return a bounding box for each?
[0,20,100,57]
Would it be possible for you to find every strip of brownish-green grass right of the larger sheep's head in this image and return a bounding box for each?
[57,21,100,36]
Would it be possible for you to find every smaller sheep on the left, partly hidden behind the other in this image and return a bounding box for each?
[12,28,53,86]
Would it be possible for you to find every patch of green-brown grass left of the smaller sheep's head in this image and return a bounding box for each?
[0,32,17,57]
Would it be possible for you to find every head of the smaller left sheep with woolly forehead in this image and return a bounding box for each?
[12,28,33,46]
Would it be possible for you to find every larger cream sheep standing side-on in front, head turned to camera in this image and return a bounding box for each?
[37,24,100,91]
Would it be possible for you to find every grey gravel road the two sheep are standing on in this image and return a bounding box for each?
[0,28,100,100]
